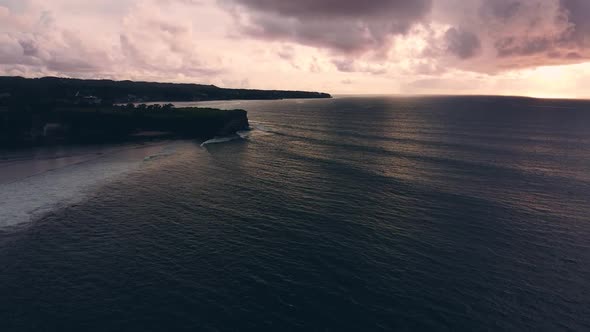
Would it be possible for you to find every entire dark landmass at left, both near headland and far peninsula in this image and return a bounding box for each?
[0,77,331,147]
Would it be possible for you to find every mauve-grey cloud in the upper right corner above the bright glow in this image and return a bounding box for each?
[491,0,590,68]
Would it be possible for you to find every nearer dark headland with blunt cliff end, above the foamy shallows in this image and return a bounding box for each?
[0,106,249,146]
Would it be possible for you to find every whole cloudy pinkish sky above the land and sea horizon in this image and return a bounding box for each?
[0,0,590,98]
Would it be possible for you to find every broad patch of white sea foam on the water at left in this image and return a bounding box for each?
[0,143,174,227]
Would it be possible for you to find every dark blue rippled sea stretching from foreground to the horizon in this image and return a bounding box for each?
[0,97,590,331]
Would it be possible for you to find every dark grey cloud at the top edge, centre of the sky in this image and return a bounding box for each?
[227,0,432,54]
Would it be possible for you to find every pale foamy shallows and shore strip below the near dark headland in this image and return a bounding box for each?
[0,140,195,230]
